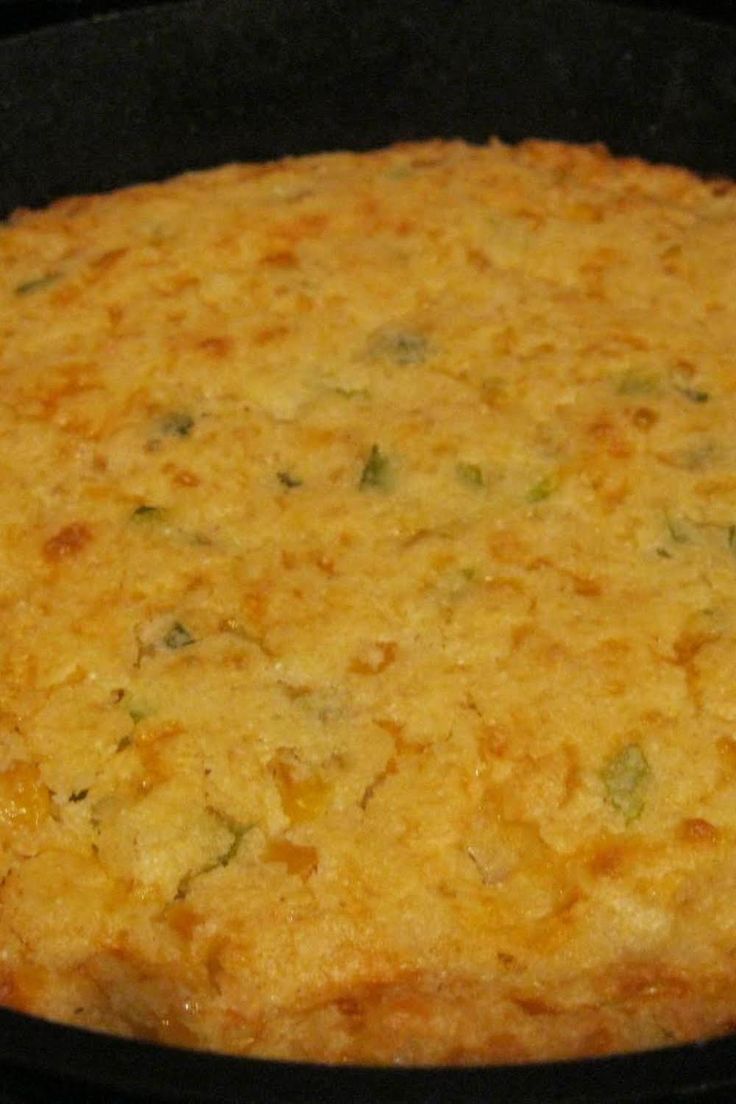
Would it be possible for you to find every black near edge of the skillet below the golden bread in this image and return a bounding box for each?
[0,1007,736,1104]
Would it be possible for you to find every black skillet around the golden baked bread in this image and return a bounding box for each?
[0,0,736,1104]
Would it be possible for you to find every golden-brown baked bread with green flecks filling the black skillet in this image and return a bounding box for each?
[0,141,736,1064]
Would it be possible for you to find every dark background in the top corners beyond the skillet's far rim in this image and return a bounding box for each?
[0,0,736,34]
